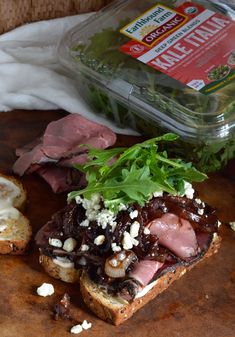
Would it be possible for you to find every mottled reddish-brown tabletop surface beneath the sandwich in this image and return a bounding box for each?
[0,111,235,337]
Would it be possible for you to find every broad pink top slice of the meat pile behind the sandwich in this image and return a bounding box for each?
[43,114,116,159]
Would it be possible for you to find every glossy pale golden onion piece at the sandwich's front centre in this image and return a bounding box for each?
[104,250,137,278]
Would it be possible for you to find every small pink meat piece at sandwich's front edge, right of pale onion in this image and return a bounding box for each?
[129,260,163,287]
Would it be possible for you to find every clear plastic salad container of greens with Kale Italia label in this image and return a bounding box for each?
[58,0,235,172]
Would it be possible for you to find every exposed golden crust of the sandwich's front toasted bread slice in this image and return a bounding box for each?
[80,235,221,325]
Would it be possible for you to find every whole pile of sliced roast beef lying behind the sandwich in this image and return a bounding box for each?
[13,114,116,193]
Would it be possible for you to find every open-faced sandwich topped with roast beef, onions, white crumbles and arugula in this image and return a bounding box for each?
[36,134,220,324]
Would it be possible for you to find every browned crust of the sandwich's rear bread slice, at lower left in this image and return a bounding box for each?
[39,253,81,283]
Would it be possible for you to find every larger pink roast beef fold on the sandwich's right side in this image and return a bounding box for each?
[148,213,198,259]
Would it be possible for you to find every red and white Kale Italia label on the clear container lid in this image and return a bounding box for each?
[120,2,235,90]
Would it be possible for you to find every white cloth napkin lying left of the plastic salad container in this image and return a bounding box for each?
[0,13,137,134]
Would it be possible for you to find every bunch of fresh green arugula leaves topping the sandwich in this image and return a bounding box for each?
[68,133,207,212]
